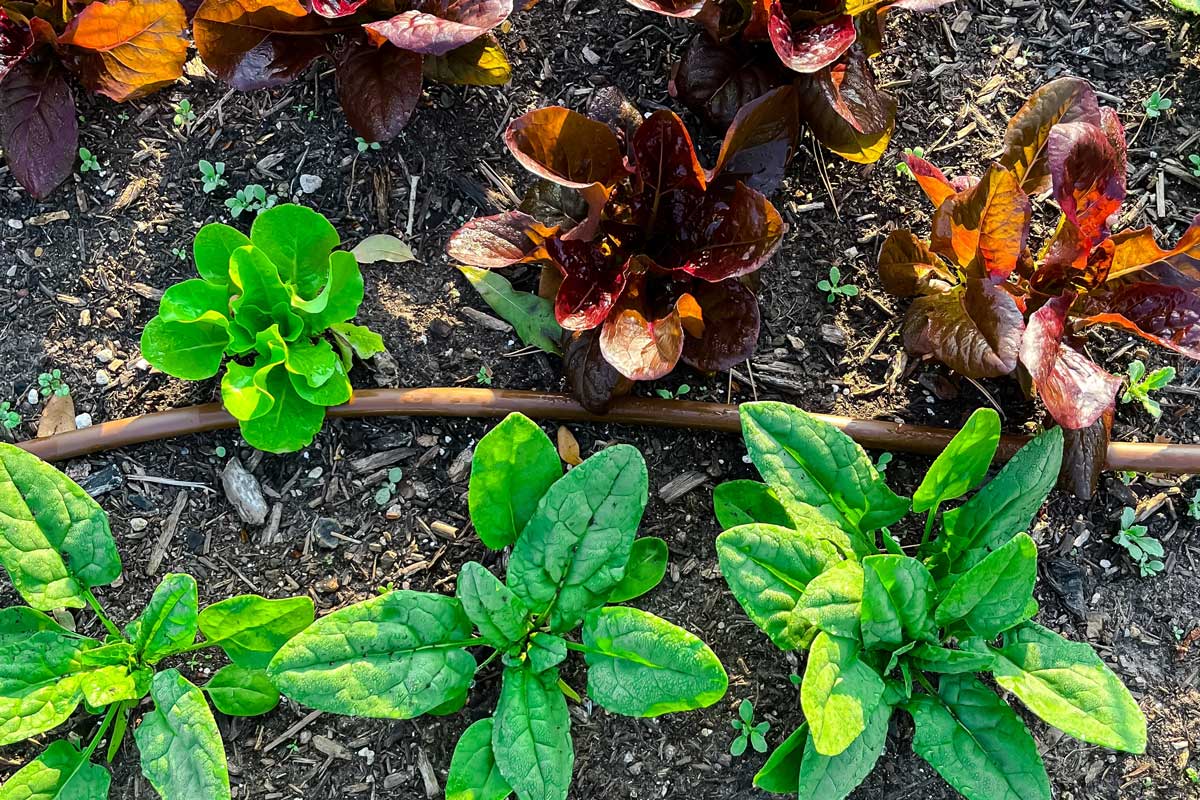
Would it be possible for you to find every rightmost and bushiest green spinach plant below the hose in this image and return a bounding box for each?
[714,403,1146,800]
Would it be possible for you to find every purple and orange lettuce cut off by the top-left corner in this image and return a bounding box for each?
[0,0,187,198]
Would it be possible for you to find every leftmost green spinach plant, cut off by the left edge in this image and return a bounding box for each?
[0,444,313,800]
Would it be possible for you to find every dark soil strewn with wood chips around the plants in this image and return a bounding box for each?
[0,0,1200,800]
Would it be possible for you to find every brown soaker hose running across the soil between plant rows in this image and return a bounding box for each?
[9,387,1200,475]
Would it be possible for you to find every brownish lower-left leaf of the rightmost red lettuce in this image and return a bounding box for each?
[904,278,1025,378]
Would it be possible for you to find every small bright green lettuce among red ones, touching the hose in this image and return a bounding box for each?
[142,205,384,452]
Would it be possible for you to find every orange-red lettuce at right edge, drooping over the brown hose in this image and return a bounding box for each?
[880,78,1200,495]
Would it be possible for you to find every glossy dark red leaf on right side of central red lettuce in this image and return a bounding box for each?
[664,182,784,283]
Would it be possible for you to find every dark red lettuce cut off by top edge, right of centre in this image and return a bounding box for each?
[629,0,949,163]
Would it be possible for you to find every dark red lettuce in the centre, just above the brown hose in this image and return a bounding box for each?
[448,88,796,410]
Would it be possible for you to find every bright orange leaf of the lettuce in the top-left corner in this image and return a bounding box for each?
[59,0,187,102]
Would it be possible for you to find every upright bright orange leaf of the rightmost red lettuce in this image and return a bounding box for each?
[930,164,1032,281]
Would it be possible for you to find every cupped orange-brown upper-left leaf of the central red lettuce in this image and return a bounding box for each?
[504,106,625,188]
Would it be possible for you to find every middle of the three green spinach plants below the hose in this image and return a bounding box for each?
[269,414,728,800]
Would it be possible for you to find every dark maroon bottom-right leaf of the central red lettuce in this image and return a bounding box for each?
[683,279,760,372]
